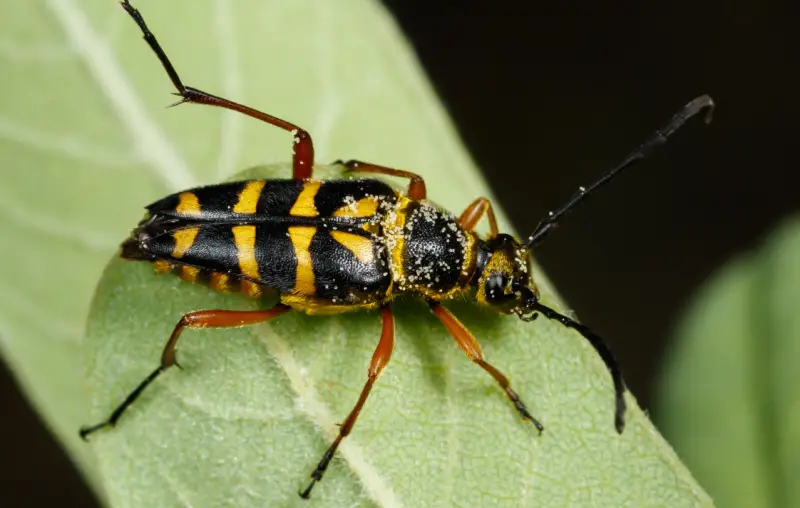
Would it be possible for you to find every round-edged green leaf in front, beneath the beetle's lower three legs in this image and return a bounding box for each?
[86,165,710,506]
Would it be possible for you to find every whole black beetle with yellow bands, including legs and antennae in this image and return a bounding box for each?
[80,0,714,498]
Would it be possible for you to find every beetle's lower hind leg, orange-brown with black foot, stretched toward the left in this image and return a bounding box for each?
[80,304,291,439]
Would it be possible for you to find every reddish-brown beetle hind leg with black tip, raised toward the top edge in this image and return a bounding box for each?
[122,0,314,180]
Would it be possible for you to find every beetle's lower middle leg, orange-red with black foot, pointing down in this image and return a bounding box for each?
[299,305,394,499]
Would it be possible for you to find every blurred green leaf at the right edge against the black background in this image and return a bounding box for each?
[658,219,800,508]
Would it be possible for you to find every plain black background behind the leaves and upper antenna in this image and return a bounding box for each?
[0,0,800,508]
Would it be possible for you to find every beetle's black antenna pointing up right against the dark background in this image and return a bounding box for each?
[525,95,714,249]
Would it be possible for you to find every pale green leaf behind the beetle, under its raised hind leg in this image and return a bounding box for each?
[0,0,484,500]
